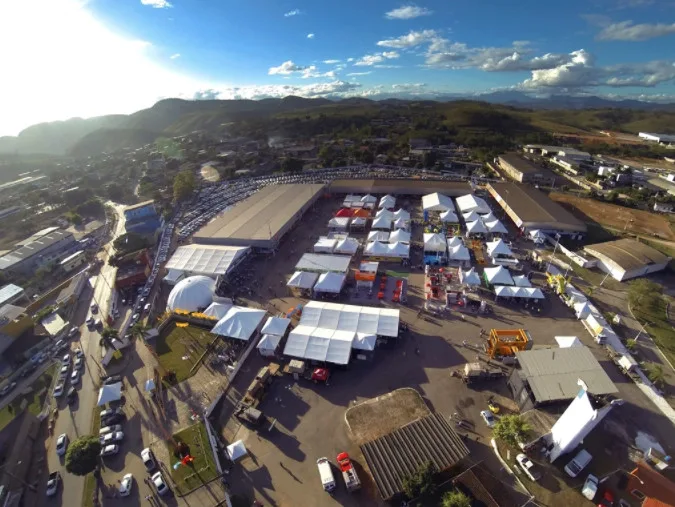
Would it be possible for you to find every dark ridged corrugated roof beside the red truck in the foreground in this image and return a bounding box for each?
[361,414,469,500]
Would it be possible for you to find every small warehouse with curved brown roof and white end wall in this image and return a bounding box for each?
[584,238,671,282]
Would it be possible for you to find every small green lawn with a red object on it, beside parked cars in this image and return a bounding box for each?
[166,423,218,493]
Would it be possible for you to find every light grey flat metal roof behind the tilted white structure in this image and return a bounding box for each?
[516,347,617,402]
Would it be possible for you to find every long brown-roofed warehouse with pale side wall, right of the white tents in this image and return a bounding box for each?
[487,183,586,239]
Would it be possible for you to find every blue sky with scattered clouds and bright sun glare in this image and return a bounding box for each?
[0,0,675,136]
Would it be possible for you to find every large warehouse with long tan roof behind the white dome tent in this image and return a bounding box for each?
[193,184,324,251]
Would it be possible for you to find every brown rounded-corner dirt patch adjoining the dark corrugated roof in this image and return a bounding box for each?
[345,389,431,445]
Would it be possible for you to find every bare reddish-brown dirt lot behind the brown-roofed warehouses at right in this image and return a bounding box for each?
[549,192,675,239]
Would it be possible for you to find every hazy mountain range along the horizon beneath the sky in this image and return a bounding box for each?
[0,91,675,156]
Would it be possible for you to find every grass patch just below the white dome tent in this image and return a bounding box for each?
[155,323,216,382]
